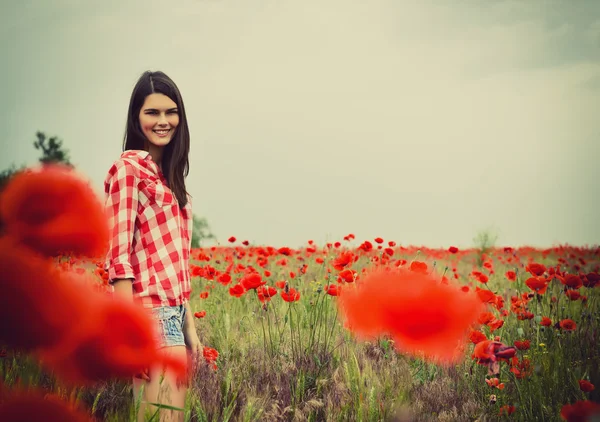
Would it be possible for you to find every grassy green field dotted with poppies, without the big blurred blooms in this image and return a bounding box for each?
[0,239,600,421]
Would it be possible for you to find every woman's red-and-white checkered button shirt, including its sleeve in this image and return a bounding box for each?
[104,150,192,308]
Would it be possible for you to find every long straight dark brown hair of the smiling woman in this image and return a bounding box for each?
[123,71,190,208]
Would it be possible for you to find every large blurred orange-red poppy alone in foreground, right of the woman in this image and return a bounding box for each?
[338,268,483,362]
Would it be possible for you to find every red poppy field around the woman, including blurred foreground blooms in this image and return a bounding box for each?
[0,167,600,421]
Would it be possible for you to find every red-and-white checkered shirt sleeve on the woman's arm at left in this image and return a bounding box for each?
[105,161,138,282]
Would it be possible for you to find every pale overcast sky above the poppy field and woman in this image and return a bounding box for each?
[0,0,600,247]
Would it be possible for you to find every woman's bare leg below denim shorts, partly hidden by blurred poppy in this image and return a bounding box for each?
[133,346,187,422]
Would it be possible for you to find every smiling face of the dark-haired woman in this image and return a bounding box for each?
[139,94,179,150]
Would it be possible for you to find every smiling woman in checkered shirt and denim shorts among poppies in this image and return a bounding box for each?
[105,72,202,420]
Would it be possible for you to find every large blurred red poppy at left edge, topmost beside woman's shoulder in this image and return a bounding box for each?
[0,165,109,256]
